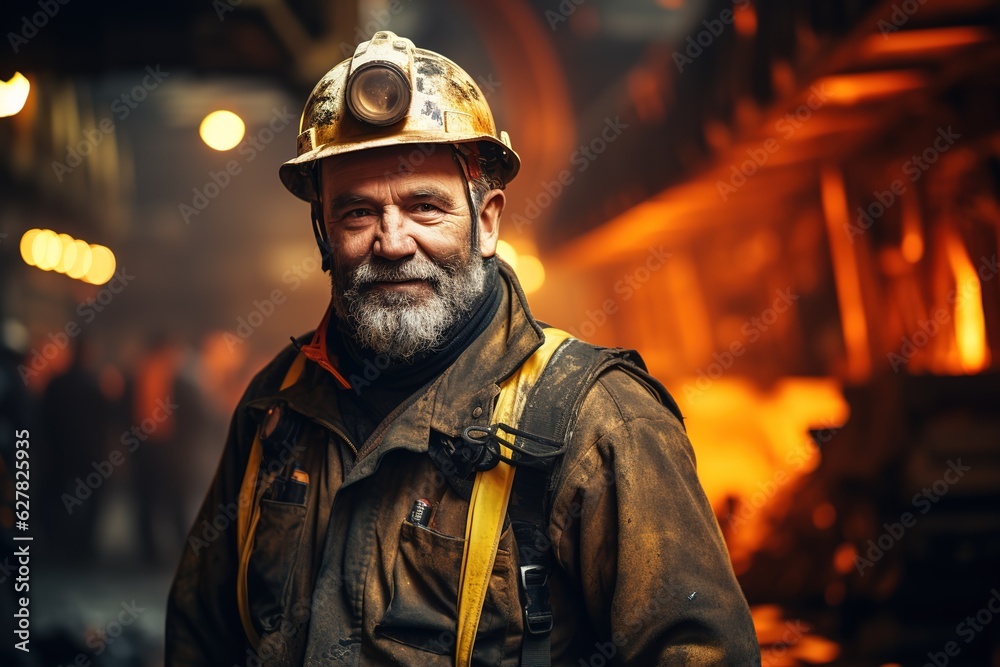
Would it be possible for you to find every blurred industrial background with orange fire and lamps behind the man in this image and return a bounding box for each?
[0,0,1000,667]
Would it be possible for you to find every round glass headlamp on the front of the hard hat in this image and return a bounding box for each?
[347,61,410,126]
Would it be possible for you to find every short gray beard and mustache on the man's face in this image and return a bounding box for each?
[331,253,486,361]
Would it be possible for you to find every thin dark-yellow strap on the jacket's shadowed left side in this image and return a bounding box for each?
[236,352,306,650]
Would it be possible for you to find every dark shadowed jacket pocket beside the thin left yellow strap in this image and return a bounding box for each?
[247,498,306,636]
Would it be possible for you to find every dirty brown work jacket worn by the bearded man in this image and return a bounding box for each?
[166,267,760,667]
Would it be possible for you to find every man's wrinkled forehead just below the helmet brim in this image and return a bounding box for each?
[320,144,465,189]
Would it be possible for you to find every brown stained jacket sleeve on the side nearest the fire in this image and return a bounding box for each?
[550,370,760,665]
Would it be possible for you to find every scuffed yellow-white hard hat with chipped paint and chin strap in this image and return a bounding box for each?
[280,30,521,204]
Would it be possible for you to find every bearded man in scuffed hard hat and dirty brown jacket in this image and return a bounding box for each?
[167,32,760,667]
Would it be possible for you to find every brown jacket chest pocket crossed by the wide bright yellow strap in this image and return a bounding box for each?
[375,521,521,665]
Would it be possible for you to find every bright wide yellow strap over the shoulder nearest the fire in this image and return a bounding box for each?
[455,329,570,667]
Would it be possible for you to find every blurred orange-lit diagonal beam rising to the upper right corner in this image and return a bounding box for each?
[551,0,1000,269]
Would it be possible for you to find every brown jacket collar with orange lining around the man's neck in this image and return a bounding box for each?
[250,261,544,482]
